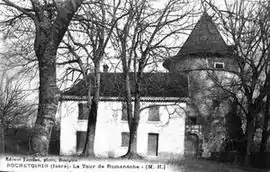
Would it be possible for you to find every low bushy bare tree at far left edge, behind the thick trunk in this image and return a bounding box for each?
[0,74,35,153]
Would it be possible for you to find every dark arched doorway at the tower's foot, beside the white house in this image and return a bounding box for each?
[185,134,199,157]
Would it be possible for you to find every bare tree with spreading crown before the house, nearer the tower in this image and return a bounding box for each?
[112,0,197,158]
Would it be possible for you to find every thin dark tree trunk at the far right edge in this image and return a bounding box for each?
[260,95,270,153]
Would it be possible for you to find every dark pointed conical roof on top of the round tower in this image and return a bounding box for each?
[178,12,230,55]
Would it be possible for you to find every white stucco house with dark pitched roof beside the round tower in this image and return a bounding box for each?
[58,72,188,159]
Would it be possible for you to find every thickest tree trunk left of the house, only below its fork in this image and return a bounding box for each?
[31,43,58,156]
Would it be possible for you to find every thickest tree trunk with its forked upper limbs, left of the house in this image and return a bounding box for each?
[30,0,83,156]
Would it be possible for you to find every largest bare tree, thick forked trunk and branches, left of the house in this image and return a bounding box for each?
[1,0,83,155]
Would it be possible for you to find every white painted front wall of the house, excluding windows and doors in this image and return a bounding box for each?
[58,101,186,159]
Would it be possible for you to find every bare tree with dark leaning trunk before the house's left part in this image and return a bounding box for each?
[58,0,126,156]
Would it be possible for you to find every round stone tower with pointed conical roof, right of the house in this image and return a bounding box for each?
[163,12,238,157]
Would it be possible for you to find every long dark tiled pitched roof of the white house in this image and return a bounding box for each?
[62,73,188,97]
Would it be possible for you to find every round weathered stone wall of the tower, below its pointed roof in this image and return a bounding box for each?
[170,57,238,157]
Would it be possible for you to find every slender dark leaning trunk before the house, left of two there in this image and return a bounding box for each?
[82,62,100,157]
